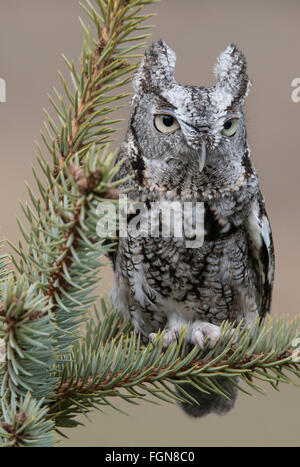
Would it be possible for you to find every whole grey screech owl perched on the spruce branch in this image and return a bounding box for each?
[112,40,274,416]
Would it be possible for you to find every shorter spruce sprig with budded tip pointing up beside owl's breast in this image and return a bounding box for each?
[9,146,121,352]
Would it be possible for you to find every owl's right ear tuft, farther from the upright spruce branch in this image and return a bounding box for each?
[214,44,251,102]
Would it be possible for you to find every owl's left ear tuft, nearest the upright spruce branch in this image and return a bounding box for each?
[133,40,176,92]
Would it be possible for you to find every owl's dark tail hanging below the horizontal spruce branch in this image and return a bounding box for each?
[177,376,238,417]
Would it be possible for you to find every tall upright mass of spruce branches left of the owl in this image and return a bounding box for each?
[0,0,155,445]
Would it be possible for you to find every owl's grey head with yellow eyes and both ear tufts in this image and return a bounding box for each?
[130,40,250,188]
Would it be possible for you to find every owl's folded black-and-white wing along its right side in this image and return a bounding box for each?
[245,194,275,317]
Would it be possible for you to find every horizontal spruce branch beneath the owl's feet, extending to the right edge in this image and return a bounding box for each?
[45,301,300,427]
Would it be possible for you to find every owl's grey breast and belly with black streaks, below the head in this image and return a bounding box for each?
[113,177,254,335]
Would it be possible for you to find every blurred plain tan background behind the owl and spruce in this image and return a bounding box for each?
[0,0,300,446]
